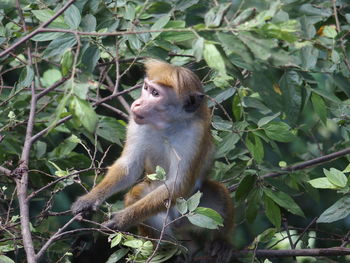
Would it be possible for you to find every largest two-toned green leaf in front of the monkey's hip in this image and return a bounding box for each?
[187,207,223,229]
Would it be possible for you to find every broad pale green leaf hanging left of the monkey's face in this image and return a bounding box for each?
[73,97,98,133]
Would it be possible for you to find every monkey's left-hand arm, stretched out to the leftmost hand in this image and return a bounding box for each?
[71,153,143,214]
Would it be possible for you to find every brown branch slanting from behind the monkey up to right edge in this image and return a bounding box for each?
[228,148,350,192]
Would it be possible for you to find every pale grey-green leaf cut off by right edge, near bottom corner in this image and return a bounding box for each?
[317,195,350,223]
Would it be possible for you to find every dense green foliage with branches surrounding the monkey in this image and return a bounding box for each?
[0,0,350,263]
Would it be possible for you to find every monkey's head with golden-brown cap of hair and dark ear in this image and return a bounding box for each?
[131,60,207,129]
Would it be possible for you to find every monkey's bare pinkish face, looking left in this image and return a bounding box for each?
[131,78,182,129]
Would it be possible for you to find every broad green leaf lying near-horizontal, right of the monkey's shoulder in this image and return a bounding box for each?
[262,122,295,142]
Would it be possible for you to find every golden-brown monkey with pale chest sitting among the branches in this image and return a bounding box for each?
[71,59,234,262]
